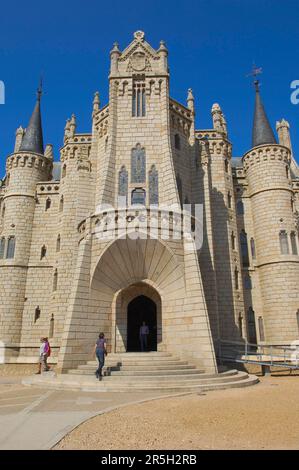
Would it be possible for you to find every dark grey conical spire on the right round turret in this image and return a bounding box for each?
[252,80,277,147]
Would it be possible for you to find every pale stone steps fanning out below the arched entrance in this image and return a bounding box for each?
[23,352,258,393]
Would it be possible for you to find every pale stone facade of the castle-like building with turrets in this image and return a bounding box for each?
[0,31,299,371]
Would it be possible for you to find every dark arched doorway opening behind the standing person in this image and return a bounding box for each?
[127,295,157,352]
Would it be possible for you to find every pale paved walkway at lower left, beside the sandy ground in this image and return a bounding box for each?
[0,378,182,450]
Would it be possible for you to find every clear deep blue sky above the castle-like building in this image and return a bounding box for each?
[0,0,299,176]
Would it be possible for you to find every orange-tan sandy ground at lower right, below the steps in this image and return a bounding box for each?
[55,373,299,450]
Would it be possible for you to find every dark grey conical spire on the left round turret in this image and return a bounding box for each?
[20,81,44,154]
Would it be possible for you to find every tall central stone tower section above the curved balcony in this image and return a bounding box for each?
[94,31,179,207]
